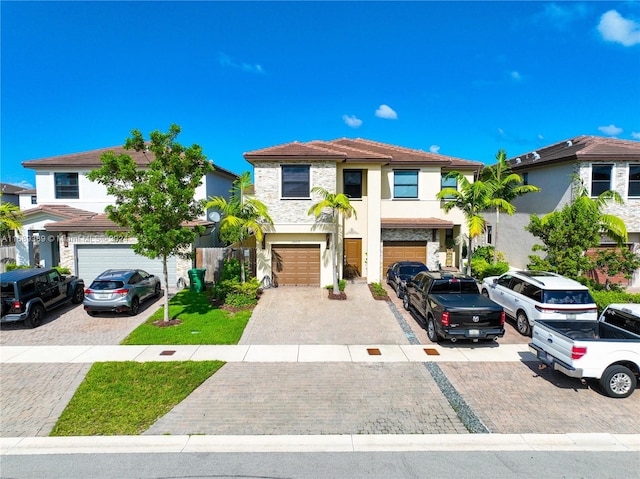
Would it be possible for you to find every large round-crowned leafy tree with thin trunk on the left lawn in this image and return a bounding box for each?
[87,125,213,321]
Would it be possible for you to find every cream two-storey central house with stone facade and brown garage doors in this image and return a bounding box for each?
[244,138,483,286]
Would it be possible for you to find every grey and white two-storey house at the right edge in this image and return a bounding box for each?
[485,136,640,287]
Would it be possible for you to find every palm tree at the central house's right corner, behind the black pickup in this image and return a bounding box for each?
[436,171,492,275]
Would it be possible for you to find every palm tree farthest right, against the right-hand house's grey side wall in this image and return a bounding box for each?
[480,150,540,264]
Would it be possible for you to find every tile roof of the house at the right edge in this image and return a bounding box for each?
[508,135,640,170]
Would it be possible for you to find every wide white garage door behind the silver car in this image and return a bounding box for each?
[76,245,178,286]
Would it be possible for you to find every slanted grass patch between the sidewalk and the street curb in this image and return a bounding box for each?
[51,361,225,436]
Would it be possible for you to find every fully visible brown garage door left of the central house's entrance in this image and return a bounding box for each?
[271,245,320,286]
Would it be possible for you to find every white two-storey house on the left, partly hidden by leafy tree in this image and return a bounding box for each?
[17,147,237,284]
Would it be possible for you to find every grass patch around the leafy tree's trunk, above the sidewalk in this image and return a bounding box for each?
[121,290,251,345]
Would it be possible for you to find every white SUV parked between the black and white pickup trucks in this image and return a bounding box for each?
[481,271,598,336]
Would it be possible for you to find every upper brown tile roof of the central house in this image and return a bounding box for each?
[244,138,483,170]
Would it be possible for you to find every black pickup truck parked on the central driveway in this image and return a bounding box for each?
[402,271,505,343]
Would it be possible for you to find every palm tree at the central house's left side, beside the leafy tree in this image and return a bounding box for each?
[205,171,273,283]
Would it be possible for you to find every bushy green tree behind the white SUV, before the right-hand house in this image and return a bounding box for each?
[525,178,627,278]
